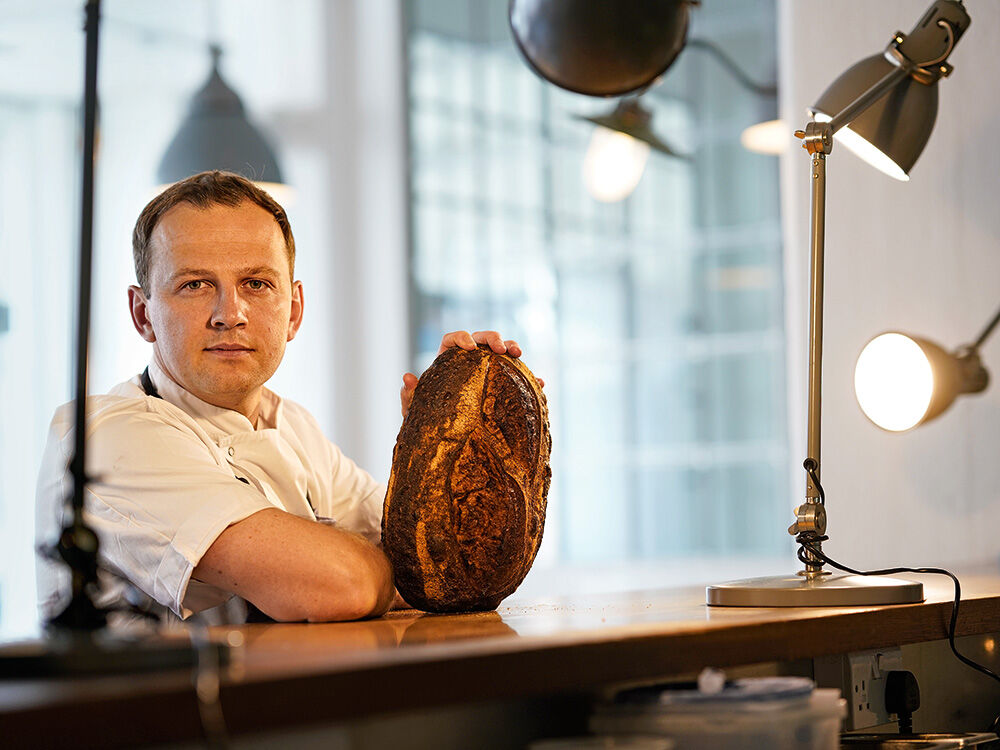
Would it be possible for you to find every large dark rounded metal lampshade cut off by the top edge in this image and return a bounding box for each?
[509,0,689,96]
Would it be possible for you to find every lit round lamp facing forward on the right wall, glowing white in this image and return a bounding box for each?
[854,311,1000,432]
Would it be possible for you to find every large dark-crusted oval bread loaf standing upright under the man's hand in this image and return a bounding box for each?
[382,346,552,612]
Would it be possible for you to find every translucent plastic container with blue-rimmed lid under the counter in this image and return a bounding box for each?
[590,677,847,750]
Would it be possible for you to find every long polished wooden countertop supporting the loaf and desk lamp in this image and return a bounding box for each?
[0,576,1000,745]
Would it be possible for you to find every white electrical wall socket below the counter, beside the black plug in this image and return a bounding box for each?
[813,647,903,731]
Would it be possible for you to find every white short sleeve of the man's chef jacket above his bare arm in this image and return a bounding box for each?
[39,400,272,617]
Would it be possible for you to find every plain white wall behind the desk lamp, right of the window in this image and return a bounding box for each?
[780,0,1000,567]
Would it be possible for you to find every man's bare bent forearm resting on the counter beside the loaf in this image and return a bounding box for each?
[194,508,395,622]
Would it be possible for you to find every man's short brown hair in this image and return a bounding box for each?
[132,170,295,297]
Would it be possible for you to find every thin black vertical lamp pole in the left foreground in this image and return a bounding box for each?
[51,0,106,630]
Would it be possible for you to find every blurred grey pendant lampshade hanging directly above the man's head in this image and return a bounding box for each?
[157,49,283,184]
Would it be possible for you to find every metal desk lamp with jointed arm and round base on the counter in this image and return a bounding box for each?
[706,0,970,607]
